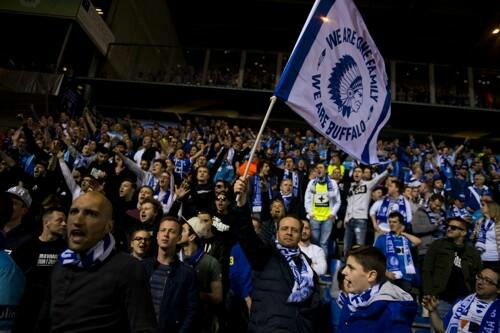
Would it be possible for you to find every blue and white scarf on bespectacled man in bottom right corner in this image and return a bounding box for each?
[446,294,500,333]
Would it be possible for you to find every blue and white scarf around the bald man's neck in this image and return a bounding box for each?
[59,233,115,268]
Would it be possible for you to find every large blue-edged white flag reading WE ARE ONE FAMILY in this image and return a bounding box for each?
[275,0,391,164]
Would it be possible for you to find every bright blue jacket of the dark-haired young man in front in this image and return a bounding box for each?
[338,282,417,333]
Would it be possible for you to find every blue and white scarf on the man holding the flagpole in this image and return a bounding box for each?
[275,240,314,303]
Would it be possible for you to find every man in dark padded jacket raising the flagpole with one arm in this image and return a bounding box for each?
[234,178,320,333]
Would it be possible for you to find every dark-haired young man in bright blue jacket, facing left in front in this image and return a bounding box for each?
[338,246,417,333]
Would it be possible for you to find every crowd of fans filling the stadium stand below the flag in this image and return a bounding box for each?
[0,104,500,332]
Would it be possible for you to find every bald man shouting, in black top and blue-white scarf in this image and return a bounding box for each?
[37,192,157,332]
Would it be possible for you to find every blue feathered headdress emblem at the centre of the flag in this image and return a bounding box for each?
[328,55,363,118]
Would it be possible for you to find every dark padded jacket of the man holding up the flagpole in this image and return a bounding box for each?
[238,204,320,333]
